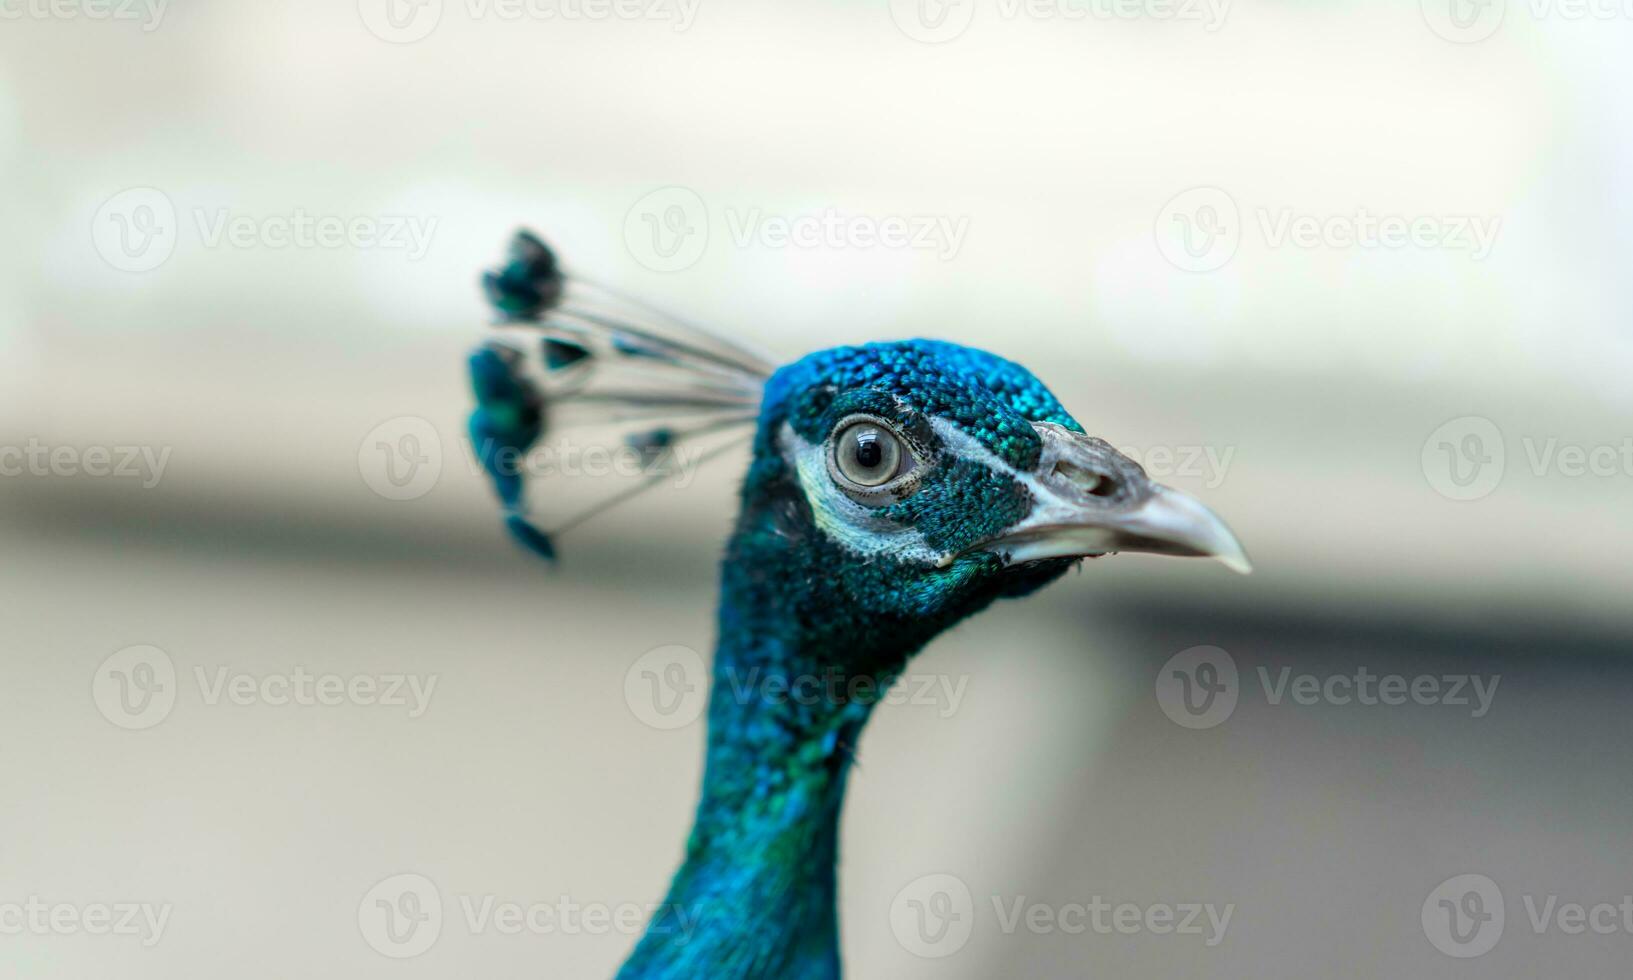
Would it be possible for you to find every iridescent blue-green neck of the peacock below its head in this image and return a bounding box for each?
[619,529,910,980]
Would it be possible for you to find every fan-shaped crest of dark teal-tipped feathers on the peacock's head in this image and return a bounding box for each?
[470,230,772,560]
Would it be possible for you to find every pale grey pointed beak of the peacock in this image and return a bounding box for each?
[980,423,1253,575]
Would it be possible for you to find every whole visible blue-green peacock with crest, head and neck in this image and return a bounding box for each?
[469,230,1249,980]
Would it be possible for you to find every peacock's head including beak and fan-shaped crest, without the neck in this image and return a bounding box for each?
[472,234,1249,663]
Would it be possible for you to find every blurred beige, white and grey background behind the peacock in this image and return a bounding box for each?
[0,0,1633,978]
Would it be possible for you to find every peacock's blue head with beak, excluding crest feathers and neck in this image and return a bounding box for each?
[715,340,1249,642]
